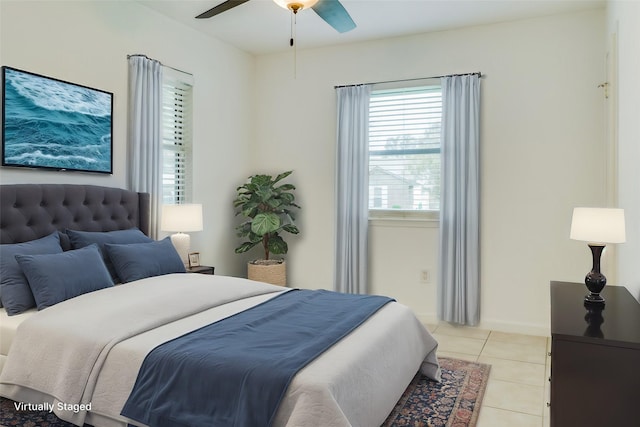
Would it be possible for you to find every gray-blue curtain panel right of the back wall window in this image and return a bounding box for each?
[438,74,480,325]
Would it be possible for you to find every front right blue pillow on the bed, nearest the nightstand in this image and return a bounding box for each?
[104,237,186,283]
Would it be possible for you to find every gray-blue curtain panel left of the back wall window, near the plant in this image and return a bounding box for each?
[334,85,371,294]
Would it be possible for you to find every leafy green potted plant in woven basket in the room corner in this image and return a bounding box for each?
[233,171,300,286]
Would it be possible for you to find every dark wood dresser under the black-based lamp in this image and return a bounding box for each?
[550,282,640,427]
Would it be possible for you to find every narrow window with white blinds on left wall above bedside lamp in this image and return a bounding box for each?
[162,67,193,204]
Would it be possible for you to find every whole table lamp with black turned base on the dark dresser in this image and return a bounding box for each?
[569,208,625,305]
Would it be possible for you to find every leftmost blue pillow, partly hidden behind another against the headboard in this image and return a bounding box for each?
[0,231,62,316]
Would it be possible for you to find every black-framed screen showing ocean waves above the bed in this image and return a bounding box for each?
[2,67,113,174]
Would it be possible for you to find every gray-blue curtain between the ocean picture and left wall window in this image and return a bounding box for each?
[128,55,162,238]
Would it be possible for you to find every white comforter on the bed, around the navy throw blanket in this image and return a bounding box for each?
[0,274,439,427]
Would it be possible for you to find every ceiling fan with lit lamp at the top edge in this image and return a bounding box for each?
[196,0,356,33]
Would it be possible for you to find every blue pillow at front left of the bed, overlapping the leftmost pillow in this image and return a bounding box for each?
[16,244,113,310]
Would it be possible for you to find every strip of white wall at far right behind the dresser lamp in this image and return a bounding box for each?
[608,1,640,301]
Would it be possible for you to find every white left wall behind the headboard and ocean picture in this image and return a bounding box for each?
[0,0,253,274]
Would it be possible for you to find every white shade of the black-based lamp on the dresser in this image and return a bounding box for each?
[569,208,626,243]
